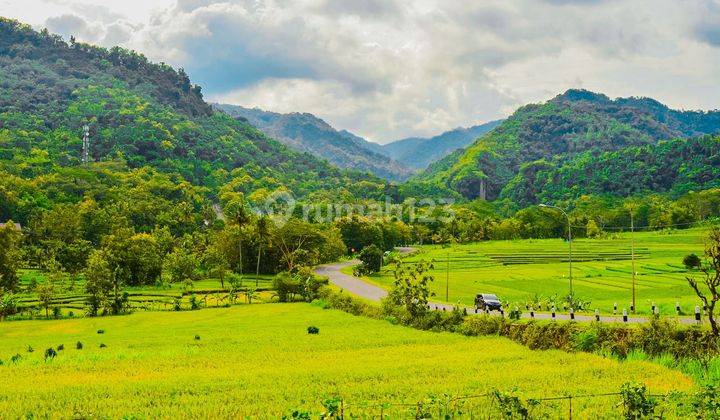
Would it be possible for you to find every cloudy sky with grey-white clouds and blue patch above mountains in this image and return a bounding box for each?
[0,0,720,143]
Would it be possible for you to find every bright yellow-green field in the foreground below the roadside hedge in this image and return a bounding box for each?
[0,304,693,418]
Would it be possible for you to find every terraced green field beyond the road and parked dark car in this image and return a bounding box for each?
[369,228,707,314]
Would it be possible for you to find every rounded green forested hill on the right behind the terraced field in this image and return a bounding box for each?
[407,90,720,205]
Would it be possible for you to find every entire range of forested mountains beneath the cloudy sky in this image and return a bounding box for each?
[0,18,720,223]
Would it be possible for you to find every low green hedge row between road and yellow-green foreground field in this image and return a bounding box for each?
[319,287,720,360]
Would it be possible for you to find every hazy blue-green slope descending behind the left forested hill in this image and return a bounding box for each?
[215,104,411,181]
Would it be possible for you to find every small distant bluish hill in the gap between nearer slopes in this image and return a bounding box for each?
[382,121,502,169]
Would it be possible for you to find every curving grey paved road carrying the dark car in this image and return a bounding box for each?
[315,247,696,325]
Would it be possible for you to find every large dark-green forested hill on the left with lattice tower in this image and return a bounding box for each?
[0,19,394,226]
